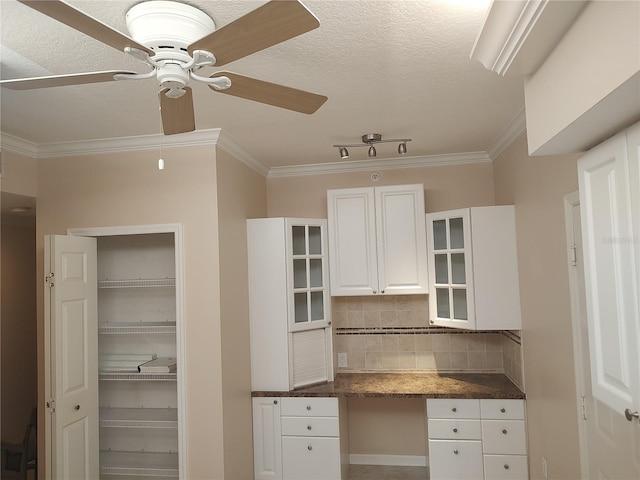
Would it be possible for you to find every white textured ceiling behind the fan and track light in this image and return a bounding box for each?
[0,0,524,168]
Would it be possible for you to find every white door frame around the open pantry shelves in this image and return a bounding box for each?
[67,223,189,478]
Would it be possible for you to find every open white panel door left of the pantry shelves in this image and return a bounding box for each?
[45,235,99,480]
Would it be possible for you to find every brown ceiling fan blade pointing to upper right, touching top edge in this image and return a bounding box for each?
[189,0,320,65]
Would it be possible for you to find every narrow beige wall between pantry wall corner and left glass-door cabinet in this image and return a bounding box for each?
[216,148,267,479]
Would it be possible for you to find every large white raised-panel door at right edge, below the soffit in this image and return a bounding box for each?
[578,125,640,412]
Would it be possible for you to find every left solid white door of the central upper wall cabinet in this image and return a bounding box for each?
[327,188,378,296]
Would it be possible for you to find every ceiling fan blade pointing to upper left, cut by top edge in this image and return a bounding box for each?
[18,0,154,56]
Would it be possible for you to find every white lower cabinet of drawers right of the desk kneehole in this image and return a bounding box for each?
[427,399,529,480]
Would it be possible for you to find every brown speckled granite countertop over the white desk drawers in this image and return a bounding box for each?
[252,373,525,399]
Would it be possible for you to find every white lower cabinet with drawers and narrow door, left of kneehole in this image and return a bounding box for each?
[253,397,348,480]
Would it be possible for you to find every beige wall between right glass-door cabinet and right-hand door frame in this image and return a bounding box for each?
[494,134,580,479]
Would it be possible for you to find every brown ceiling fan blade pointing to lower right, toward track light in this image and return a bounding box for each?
[209,72,327,114]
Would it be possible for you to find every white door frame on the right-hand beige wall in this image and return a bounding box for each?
[564,191,589,478]
